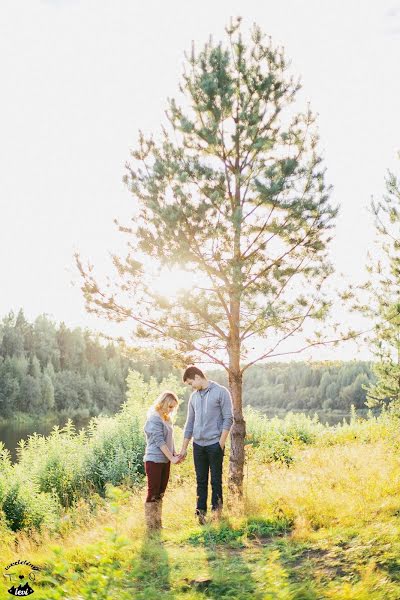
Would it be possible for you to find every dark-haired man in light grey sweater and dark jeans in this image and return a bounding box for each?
[179,366,233,525]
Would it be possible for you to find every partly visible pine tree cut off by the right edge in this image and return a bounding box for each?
[357,154,400,413]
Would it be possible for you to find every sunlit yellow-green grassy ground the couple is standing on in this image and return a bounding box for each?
[0,412,400,600]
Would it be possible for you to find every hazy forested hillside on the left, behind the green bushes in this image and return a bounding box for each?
[0,310,181,419]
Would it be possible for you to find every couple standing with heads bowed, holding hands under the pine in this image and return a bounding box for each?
[143,366,233,530]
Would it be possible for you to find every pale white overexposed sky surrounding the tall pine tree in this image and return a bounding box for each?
[0,0,400,360]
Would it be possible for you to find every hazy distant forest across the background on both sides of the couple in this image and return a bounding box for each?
[0,310,373,422]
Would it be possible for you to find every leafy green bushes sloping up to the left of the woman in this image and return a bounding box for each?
[0,371,183,530]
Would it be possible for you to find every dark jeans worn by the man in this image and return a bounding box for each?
[193,442,225,512]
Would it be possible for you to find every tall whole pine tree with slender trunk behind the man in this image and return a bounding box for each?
[76,19,336,493]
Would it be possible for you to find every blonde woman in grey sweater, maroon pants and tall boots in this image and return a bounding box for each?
[143,390,180,530]
